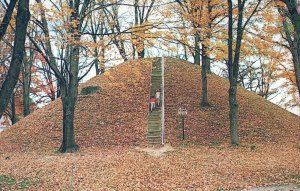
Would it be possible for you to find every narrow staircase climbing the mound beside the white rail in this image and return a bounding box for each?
[147,59,162,145]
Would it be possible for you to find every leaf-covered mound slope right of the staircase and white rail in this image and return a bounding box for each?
[165,59,300,145]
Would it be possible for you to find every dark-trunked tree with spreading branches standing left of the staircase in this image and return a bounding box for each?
[30,0,118,152]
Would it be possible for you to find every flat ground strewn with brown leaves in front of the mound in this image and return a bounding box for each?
[0,145,300,190]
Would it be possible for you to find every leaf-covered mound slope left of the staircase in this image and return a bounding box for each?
[0,60,152,152]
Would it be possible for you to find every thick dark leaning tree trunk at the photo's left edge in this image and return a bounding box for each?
[0,0,30,119]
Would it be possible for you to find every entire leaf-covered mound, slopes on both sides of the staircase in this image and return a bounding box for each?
[0,59,300,152]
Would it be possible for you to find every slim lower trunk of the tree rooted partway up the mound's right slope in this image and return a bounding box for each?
[201,45,210,107]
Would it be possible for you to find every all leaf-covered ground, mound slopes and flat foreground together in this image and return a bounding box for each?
[0,59,300,190]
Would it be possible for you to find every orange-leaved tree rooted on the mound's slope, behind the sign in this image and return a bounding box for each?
[176,0,225,107]
